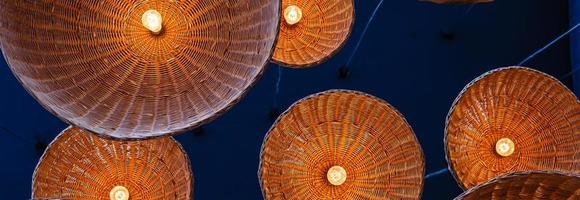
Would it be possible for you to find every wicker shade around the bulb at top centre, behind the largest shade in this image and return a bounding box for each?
[272,0,354,68]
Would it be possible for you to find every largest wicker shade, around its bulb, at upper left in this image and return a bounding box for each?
[0,0,281,139]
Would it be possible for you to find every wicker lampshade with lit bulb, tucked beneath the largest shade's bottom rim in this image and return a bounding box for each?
[32,127,193,200]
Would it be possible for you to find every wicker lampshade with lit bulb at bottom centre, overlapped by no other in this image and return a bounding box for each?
[259,90,425,199]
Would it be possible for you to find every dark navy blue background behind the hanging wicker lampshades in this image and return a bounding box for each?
[0,0,580,200]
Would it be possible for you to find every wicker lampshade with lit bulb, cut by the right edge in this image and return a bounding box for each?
[445,67,580,189]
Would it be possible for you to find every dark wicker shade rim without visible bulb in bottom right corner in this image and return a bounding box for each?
[456,171,580,200]
